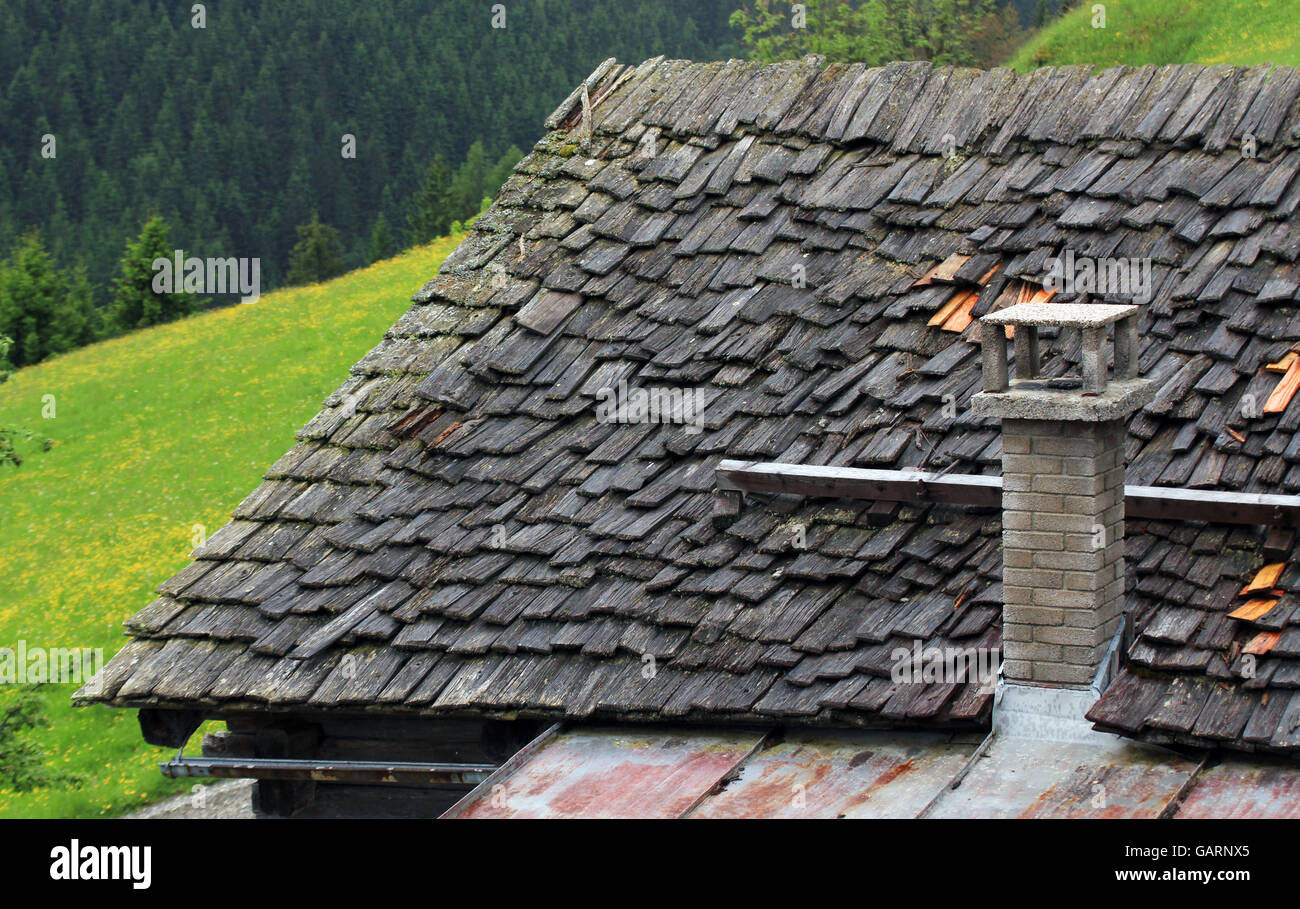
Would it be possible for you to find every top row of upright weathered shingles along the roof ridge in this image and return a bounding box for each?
[574,55,1300,153]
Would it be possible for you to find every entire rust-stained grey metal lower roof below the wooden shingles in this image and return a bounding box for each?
[445,727,1300,818]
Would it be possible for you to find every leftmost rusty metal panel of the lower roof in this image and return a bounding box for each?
[443,727,764,818]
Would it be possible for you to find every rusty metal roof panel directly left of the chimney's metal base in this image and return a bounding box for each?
[690,731,976,818]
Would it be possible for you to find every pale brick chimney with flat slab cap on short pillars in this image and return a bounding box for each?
[971,303,1156,697]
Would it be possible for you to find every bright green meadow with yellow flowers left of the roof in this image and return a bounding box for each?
[0,237,460,817]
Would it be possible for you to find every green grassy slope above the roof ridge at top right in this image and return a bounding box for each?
[1010,0,1300,72]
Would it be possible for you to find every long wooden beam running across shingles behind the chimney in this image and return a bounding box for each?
[715,460,1300,527]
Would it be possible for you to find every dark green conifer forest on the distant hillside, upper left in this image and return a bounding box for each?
[0,0,743,313]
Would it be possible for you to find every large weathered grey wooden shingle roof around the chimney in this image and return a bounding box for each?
[82,60,1300,752]
